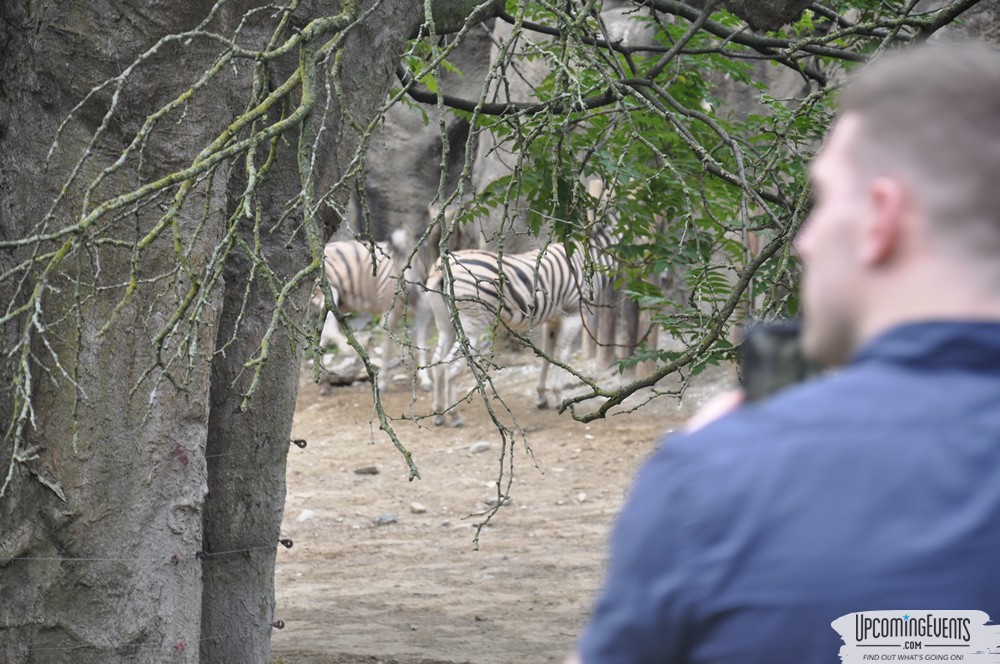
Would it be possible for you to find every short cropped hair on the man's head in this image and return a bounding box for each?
[840,44,1000,253]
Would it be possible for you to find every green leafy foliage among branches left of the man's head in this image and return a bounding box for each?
[388,0,969,413]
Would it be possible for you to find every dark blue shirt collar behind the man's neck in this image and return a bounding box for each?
[851,321,1000,371]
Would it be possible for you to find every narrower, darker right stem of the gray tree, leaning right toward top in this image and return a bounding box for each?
[201,1,422,664]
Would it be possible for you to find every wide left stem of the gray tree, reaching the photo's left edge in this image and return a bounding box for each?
[0,1,225,663]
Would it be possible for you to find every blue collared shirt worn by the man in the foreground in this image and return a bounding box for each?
[579,322,1000,664]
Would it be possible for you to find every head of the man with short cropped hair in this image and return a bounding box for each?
[796,45,1000,364]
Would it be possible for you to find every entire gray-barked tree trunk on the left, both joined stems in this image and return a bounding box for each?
[0,0,422,663]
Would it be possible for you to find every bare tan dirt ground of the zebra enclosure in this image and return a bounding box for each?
[272,350,725,664]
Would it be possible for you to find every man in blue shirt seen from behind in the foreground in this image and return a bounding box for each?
[578,46,1000,664]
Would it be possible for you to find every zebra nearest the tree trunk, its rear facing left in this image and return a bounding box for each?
[311,229,431,389]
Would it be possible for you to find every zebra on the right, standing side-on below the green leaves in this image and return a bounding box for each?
[427,224,615,426]
